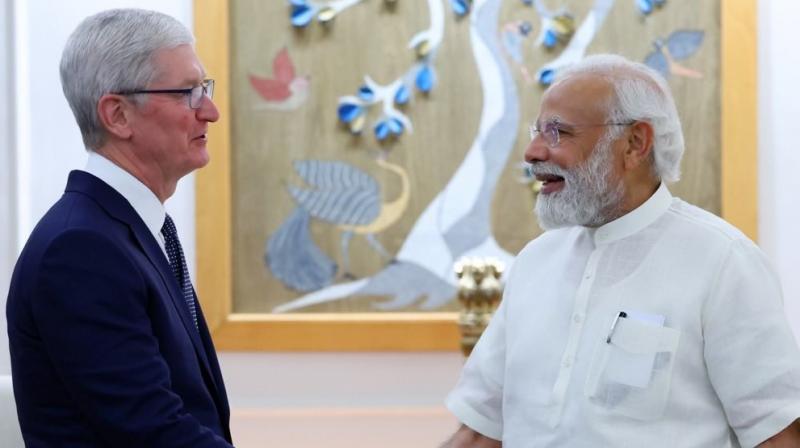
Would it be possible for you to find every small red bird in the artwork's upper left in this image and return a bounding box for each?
[249,47,311,110]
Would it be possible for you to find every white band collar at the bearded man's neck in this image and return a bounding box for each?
[594,183,672,245]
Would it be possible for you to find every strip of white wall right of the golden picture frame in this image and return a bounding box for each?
[760,0,800,341]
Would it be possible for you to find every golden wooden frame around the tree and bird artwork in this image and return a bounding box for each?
[194,0,758,351]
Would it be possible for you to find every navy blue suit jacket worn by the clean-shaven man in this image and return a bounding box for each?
[6,171,231,448]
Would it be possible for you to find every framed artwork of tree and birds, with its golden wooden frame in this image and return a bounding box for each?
[195,0,757,351]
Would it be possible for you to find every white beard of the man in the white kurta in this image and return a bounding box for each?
[531,136,625,230]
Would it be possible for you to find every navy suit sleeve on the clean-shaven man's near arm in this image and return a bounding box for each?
[31,230,231,448]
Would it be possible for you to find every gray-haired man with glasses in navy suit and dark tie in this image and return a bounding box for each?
[6,9,232,448]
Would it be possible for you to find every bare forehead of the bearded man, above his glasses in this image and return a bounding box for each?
[537,74,613,124]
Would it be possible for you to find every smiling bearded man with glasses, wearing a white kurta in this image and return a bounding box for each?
[447,56,800,448]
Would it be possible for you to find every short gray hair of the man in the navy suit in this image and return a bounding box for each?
[60,9,194,149]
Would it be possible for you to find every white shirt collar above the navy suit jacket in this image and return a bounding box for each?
[86,151,167,241]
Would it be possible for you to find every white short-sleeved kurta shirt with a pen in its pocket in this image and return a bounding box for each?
[447,185,800,448]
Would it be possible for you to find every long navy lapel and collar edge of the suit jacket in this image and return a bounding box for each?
[66,171,219,395]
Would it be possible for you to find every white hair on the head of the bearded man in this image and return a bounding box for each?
[554,54,685,182]
